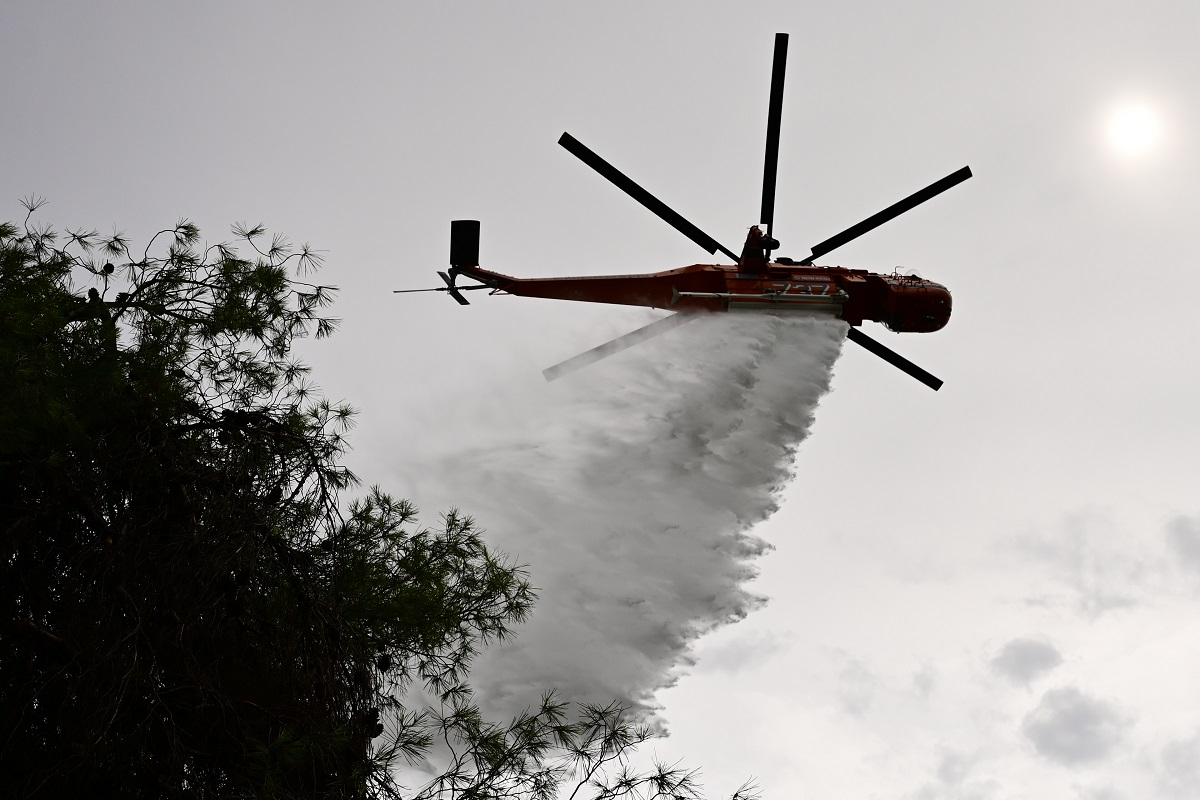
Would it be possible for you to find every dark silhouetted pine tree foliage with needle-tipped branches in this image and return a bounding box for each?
[0,201,758,800]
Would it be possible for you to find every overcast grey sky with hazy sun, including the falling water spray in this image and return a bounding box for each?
[0,0,1200,800]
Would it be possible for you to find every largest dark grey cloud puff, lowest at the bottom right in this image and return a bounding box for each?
[1021,687,1129,766]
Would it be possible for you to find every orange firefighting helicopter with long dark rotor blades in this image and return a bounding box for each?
[398,34,971,391]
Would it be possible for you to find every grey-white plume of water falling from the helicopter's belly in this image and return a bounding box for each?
[403,314,846,716]
